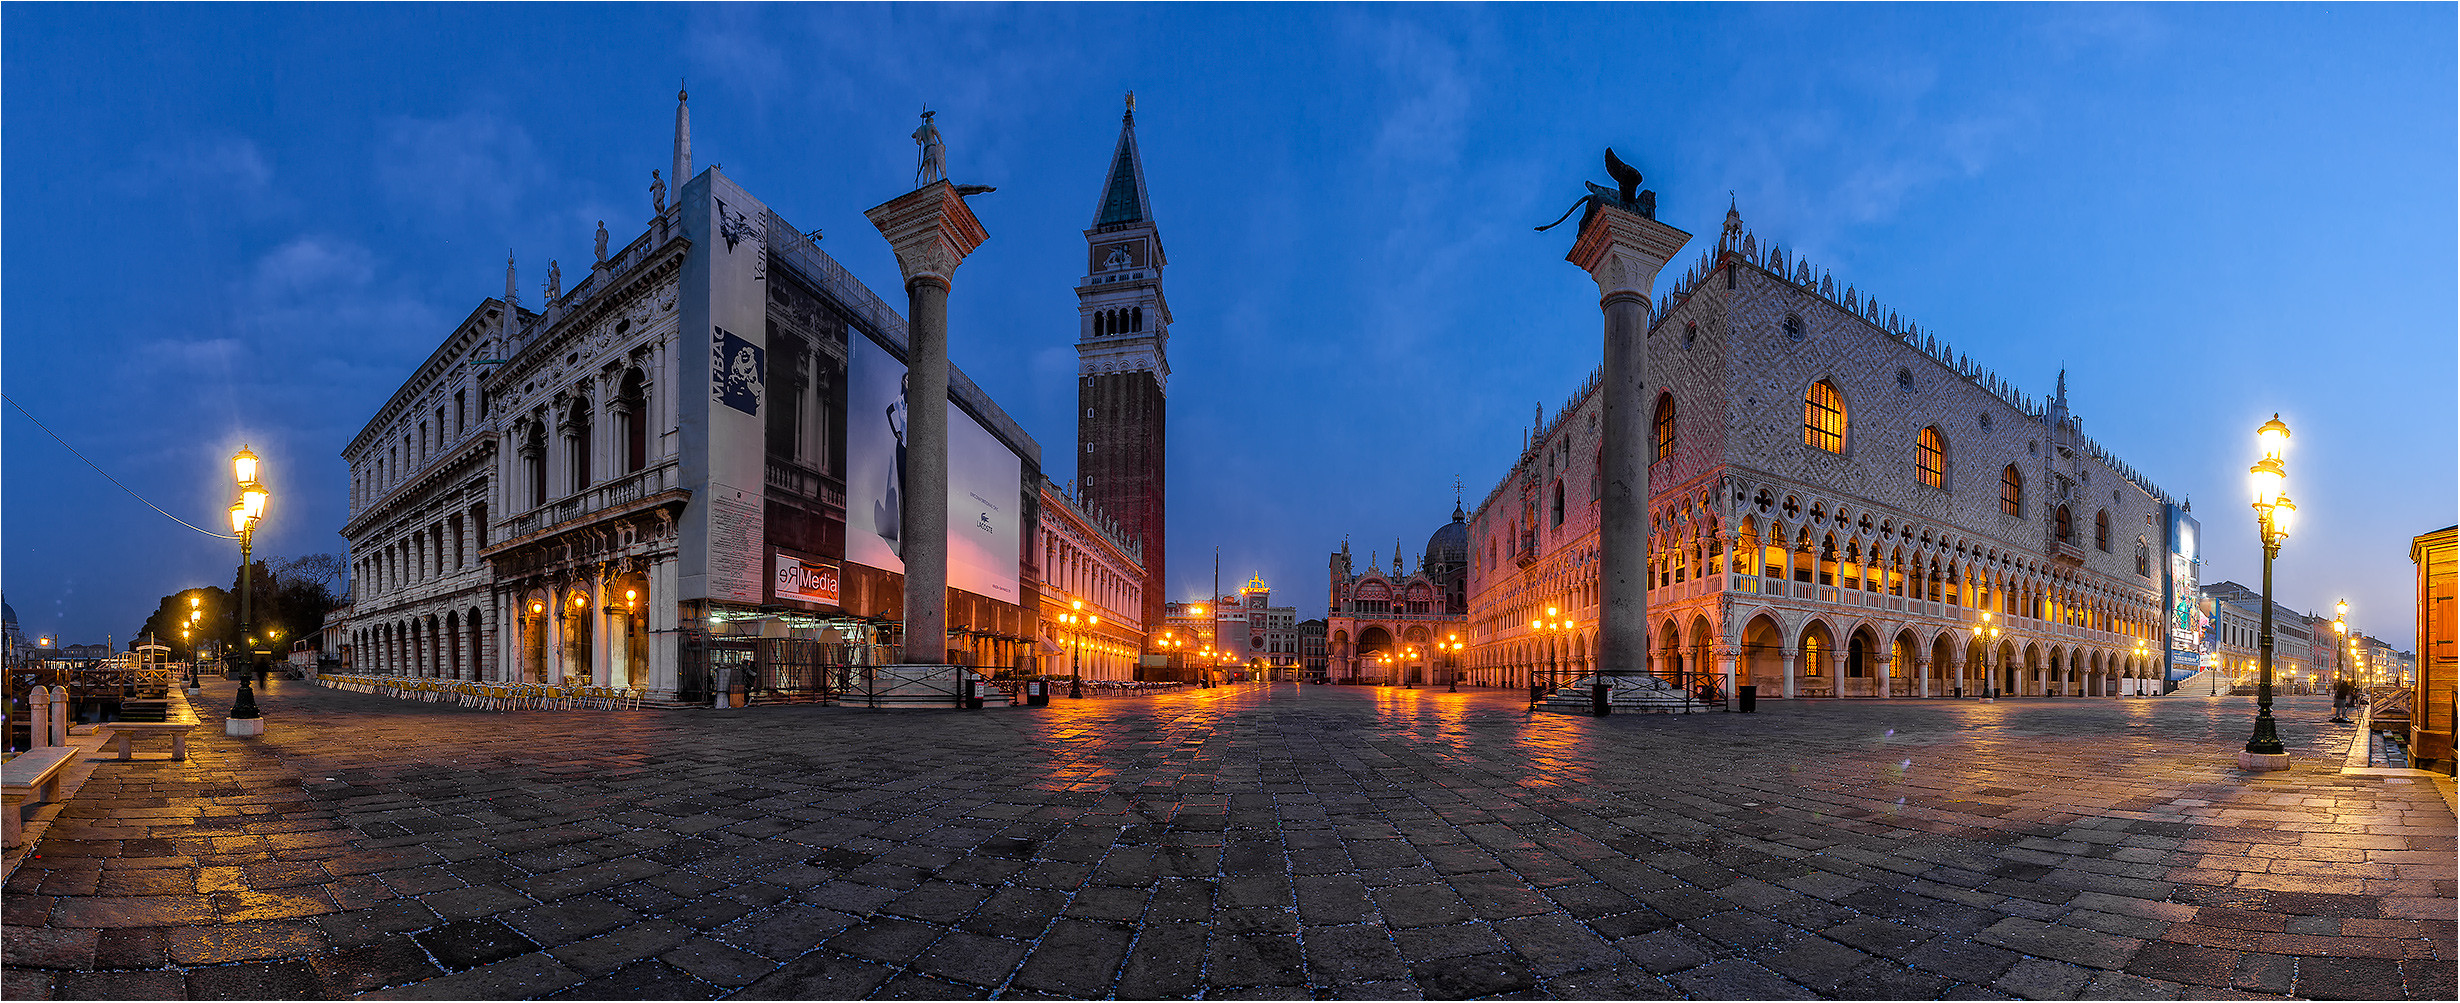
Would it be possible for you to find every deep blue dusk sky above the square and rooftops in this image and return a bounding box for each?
[0,5,2460,647]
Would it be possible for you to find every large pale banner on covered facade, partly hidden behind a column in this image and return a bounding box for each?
[846,332,1023,602]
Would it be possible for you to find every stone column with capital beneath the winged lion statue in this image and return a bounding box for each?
[1565,194,1690,676]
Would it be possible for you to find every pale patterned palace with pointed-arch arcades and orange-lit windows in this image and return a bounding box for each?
[1464,209,2172,698]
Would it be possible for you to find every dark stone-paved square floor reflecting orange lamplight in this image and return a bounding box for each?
[5,681,2455,998]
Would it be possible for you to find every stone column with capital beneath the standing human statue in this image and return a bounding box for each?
[863,179,989,666]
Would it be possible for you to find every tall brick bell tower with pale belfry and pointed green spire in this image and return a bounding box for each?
[1077,93,1171,632]
